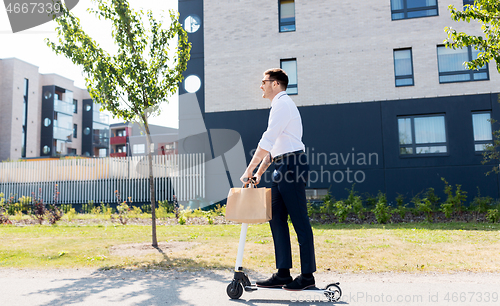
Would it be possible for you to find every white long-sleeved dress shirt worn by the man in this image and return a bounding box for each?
[259,91,305,158]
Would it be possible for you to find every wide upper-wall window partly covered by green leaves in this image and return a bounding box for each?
[437,46,490,83]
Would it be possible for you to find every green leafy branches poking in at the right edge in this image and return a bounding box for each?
[444,0,500,174]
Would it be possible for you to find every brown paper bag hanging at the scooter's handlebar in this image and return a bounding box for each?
[226,188,272,223]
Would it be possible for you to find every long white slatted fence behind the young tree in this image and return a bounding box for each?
[0,153,205,204]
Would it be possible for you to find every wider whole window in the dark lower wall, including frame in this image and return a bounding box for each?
[398,115,448,155]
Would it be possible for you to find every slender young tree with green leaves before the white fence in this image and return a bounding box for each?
[46,0,191,247]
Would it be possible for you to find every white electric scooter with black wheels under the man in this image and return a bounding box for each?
[226,223,342,302]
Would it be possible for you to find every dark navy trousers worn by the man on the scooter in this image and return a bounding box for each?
[269,154,316,273]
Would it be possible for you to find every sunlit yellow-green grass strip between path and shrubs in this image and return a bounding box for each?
[0,223,500,273]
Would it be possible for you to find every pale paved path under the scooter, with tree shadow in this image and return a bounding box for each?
[0,269,500,306]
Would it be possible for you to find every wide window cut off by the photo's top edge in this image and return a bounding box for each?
[391,0,438,20]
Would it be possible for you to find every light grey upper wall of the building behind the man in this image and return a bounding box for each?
[203,0,500,112]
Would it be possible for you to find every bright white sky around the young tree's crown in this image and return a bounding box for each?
[0,0,179,128]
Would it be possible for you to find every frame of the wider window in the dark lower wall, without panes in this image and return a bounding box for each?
[396,113,450,158]
